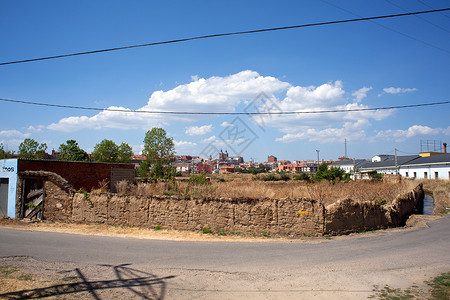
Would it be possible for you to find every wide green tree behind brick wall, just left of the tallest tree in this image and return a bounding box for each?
[92,139,133,163]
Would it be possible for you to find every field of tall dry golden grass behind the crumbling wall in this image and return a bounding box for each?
[118,175,417,205]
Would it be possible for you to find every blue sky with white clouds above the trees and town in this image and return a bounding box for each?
[0,0,450,161]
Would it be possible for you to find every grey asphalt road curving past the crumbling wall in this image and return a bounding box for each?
[0,216,450,299]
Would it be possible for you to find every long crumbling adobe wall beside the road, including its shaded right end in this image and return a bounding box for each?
[46,185,423,237]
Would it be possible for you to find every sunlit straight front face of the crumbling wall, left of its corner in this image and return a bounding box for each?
[72,193,323,236]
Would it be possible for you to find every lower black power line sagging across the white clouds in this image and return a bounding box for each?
[0,98,450,115]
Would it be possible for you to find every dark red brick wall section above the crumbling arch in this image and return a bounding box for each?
[18,159,134,191]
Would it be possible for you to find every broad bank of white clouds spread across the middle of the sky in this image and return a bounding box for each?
[29,70,432,148]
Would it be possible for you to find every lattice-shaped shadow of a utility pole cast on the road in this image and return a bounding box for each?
[0,264,175,299]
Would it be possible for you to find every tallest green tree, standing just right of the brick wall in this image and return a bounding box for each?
[143,127,175,178]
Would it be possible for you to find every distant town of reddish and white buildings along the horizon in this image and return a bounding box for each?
[1,142,450,179]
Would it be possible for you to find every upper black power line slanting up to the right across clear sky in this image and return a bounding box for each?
[0,8,450,66]
